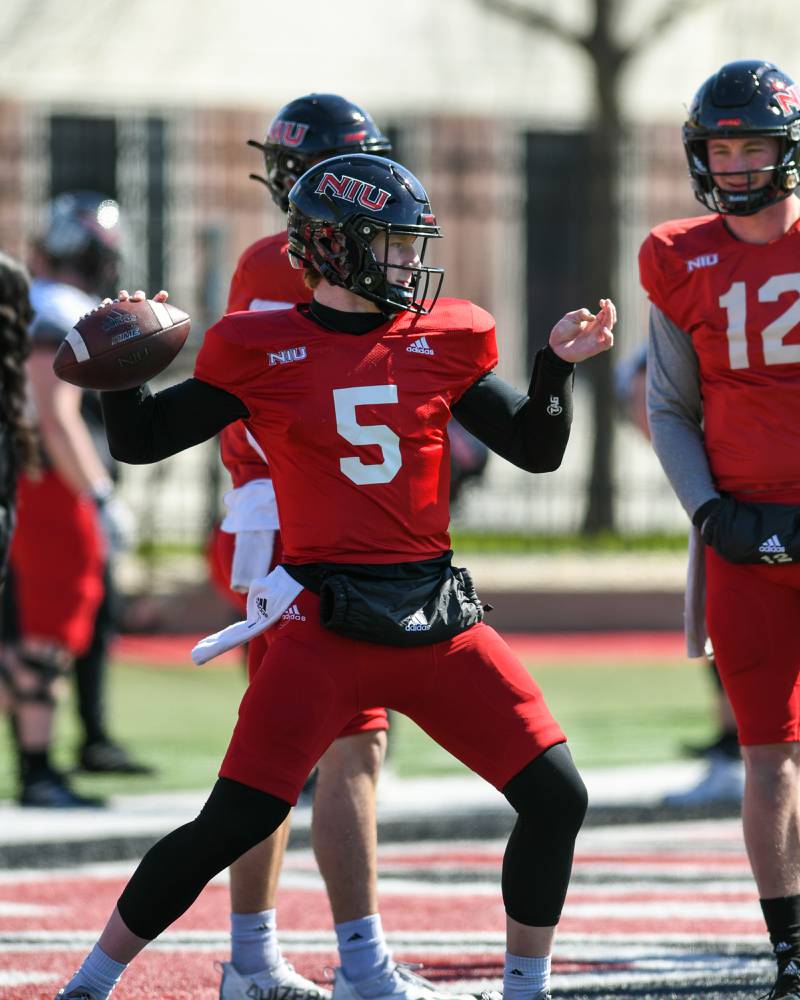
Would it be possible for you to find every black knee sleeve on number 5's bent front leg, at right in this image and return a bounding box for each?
[503,743,588,927]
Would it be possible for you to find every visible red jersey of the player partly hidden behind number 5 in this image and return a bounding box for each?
[225,230,311,487]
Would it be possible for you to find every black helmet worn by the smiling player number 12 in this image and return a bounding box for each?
[683,60,800,215]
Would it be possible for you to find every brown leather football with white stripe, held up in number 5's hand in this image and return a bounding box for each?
[53,299,190,390]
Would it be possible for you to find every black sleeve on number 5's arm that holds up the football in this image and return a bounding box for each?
[100,378,249,465]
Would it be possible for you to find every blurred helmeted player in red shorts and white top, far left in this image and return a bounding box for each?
[3,192,149,807]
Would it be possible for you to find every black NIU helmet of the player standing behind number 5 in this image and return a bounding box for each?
[248,94,392,212]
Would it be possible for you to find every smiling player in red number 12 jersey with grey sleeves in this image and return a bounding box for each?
[640,61,800,998]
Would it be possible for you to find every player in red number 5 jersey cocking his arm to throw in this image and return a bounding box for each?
[59,155,615,1000]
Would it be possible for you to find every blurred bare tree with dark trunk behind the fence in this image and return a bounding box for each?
[476,0,715,534]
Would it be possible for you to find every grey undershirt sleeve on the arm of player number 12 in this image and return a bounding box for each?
[647,306,719,518]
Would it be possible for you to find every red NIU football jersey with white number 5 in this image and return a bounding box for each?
[195,299,497,563]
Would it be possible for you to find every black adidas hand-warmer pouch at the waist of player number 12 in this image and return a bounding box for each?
[692,496,800,564]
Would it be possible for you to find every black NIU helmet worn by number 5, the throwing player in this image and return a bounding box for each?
[288,154,444,315]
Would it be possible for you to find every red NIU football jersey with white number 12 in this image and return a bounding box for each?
[639,215,800,492]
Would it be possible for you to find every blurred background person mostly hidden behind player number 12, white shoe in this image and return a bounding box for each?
[615,344,744,807]
